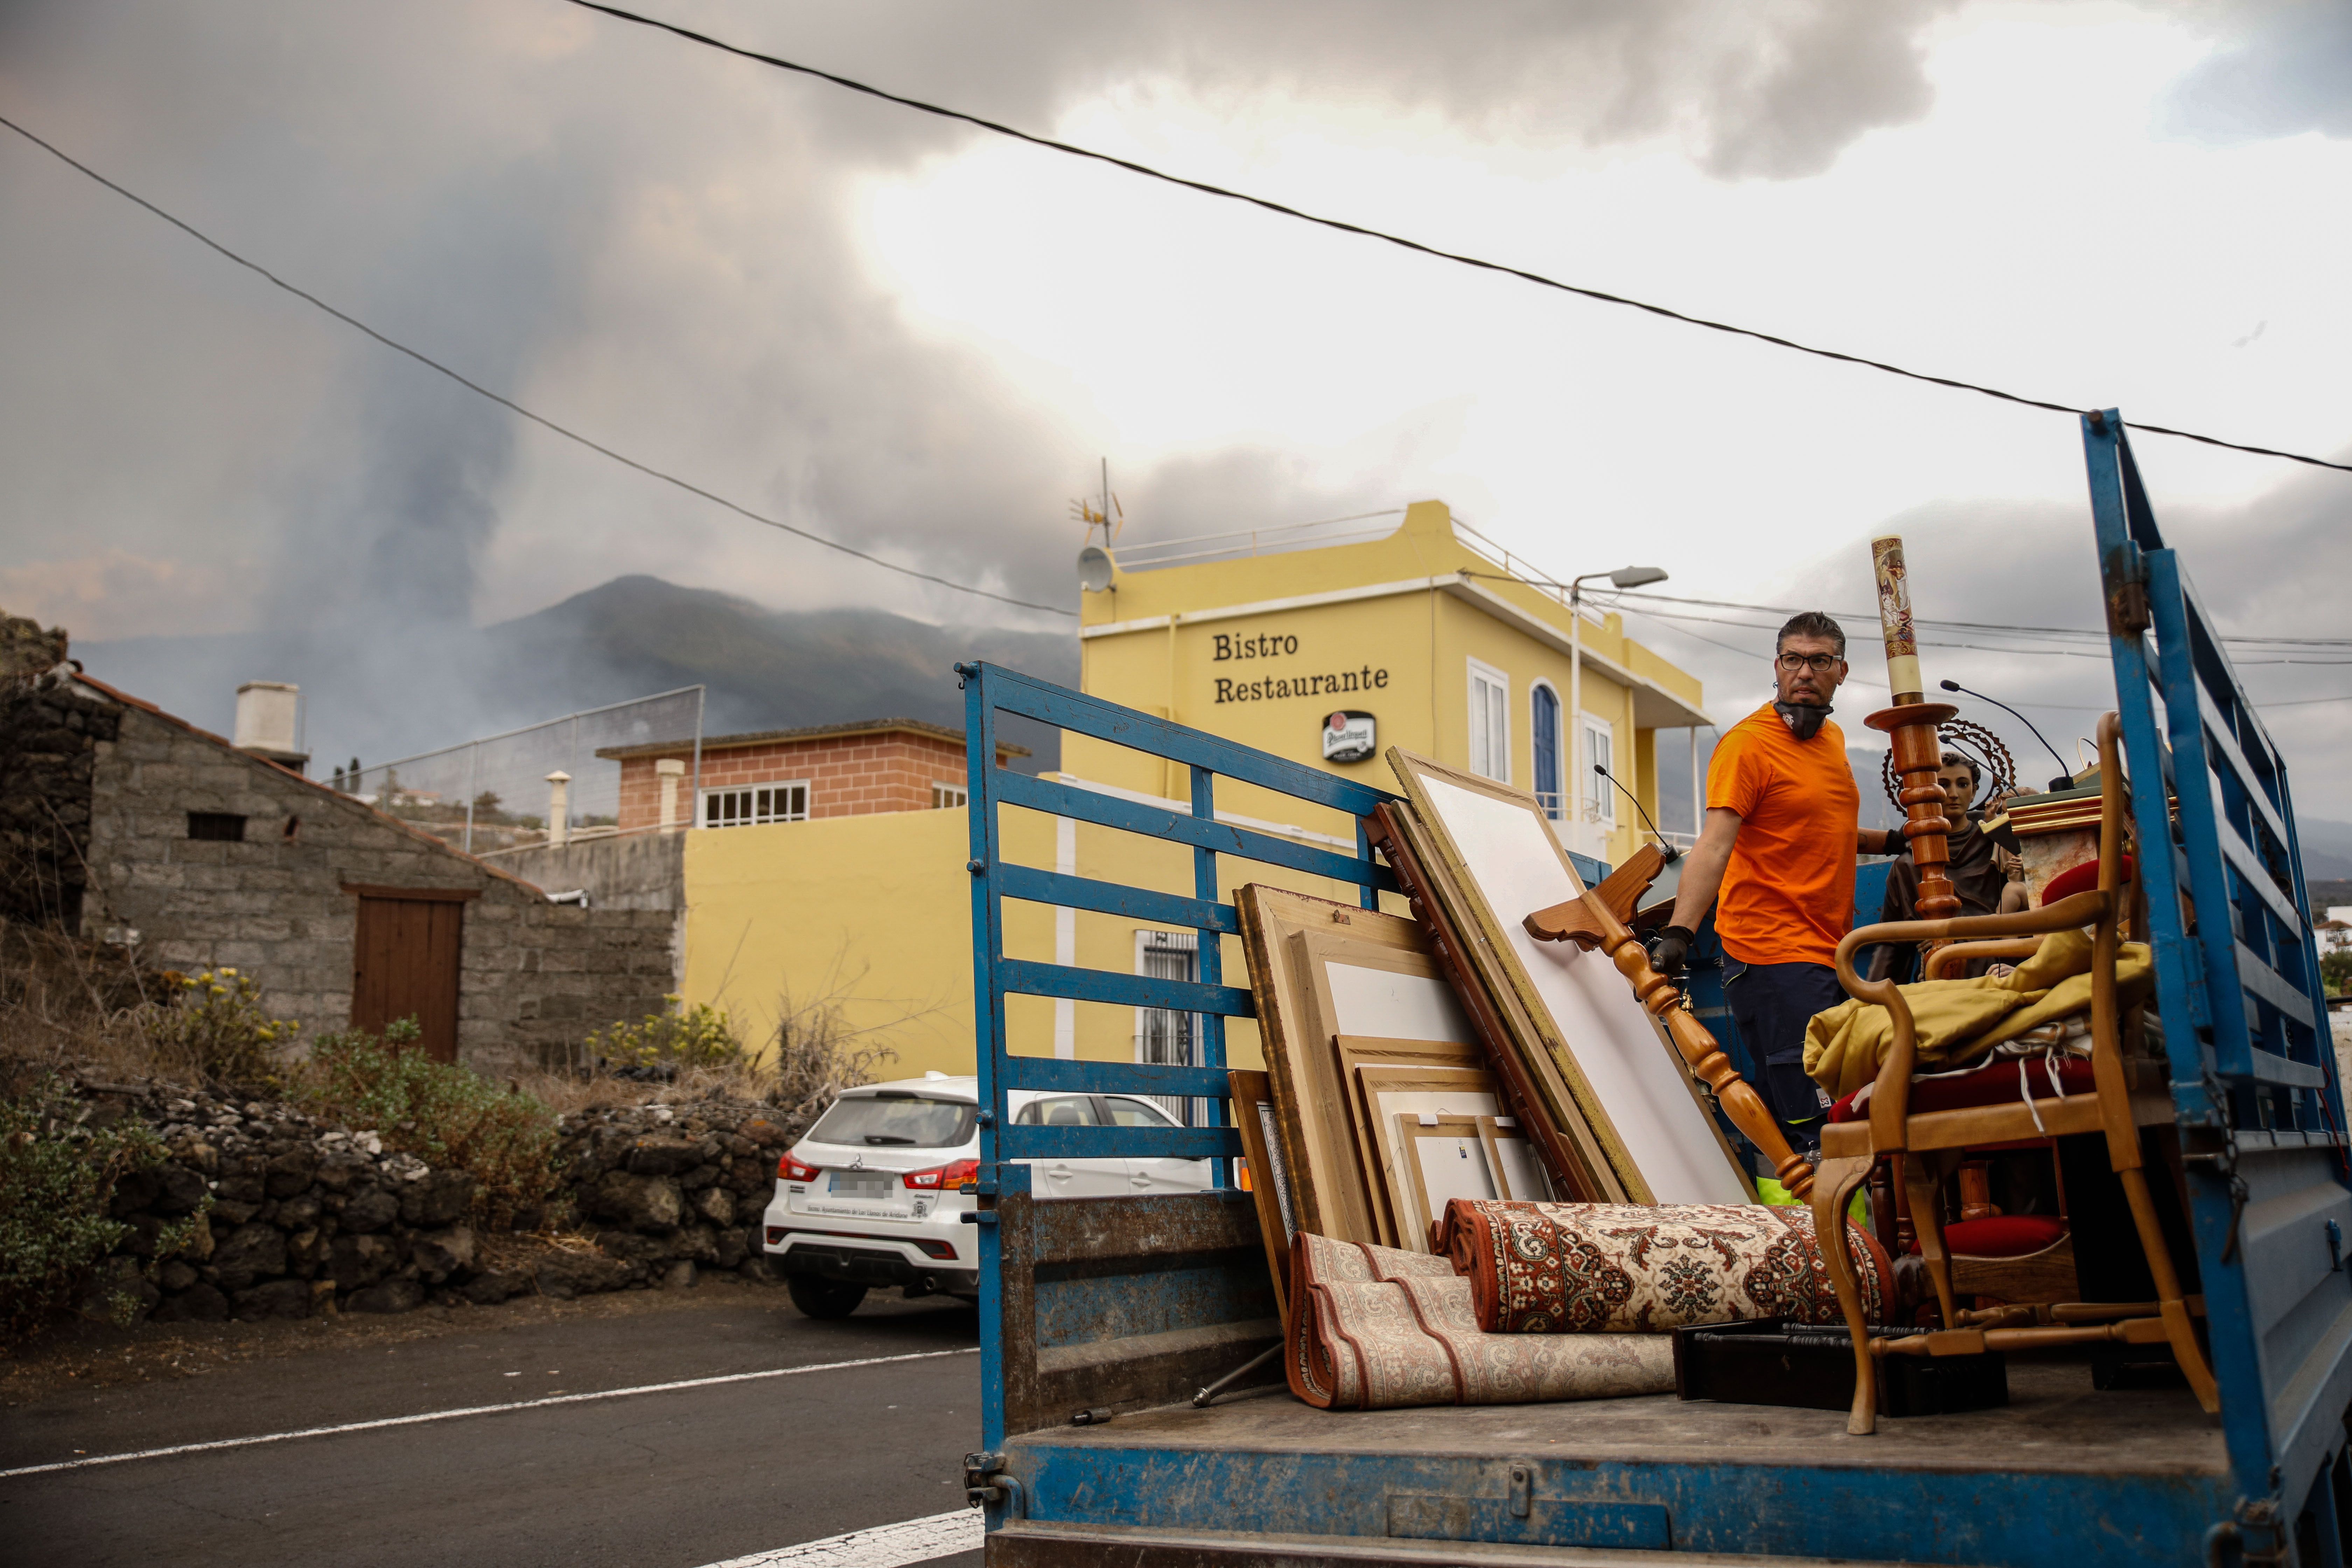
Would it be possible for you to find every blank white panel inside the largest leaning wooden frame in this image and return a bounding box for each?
[1423,774,1755,1204]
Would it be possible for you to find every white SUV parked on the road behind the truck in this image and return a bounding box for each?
[760,1072,1209,1316]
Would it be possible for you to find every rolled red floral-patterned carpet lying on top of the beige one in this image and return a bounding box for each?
[1437,1199,1893,1335]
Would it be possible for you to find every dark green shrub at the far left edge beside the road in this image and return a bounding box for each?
[0,1074,212,1345]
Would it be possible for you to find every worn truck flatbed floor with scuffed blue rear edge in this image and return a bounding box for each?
[990,1357,2234,1568]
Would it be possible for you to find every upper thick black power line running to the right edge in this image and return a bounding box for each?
[572,0,2352,472]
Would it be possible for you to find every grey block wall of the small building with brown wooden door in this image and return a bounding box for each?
[78,682,677,1074]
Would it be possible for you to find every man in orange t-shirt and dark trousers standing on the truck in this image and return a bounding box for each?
[1656,611,1903,1159]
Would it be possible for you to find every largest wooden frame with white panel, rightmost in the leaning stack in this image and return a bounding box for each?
[1388,748,1755,1204]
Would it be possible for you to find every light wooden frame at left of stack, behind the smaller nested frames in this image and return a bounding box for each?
[1232,882,1444,1244]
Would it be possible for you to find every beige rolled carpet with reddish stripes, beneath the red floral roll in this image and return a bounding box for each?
[1284,1211,1675,1410]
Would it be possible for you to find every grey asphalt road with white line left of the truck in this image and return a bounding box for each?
[0,1286,981,1568]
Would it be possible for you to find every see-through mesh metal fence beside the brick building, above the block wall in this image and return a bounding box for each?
[327,686,703,853]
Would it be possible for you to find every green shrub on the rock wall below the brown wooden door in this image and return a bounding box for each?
[296,1018,555,1225]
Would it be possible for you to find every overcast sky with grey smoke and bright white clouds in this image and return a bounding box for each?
[0,0,2352,818]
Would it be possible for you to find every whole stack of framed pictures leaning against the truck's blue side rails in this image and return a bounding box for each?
[1232,750,1755,1279]
